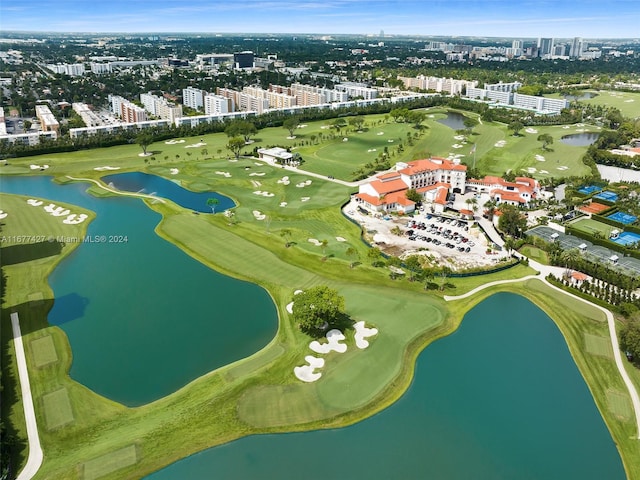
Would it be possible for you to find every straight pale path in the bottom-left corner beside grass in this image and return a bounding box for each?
[11,312,44,480]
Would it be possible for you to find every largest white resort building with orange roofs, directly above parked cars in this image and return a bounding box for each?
[355,157,467,213]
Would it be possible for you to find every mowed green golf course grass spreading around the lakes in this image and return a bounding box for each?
[2,109,640,479]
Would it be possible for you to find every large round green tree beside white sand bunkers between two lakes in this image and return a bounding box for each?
[292,285,345,335]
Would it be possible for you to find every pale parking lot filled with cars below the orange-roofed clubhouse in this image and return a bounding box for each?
[344,202,507,270]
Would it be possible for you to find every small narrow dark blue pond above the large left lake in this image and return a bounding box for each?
[101,172,235,213]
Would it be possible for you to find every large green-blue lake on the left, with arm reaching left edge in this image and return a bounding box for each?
[0,176,277,406]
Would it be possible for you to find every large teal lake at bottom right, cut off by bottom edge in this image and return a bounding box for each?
[147,293,625,480]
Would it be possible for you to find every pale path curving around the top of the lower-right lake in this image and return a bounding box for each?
[444,253,640,439]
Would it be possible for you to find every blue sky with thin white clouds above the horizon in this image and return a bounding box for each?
[0,0,640,38]
